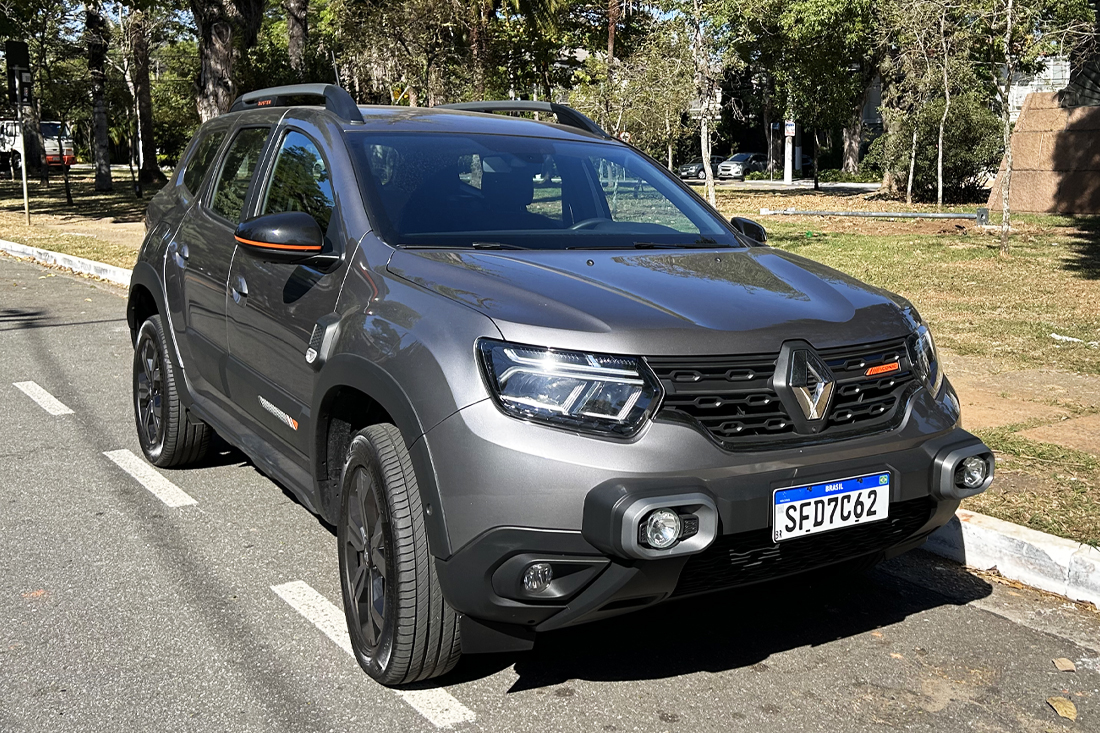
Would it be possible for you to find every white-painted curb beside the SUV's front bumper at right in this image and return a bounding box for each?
[924,510,1100,608]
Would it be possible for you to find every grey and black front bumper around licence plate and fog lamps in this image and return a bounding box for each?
[426,378,988,642]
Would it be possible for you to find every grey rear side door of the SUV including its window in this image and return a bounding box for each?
[169,125,271,401]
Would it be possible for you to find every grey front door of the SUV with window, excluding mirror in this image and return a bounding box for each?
[228,129,348,457]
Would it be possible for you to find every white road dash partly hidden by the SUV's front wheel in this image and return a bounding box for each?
[272,580,475,727]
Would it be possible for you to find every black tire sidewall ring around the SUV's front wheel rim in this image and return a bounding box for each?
[337,435,398,680]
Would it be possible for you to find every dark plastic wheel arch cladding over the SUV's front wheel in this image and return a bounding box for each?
[312,353,451,558]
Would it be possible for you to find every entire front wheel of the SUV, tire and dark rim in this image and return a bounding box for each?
[337,424,461,687]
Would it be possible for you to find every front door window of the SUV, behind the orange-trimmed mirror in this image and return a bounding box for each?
[260,131,334,231]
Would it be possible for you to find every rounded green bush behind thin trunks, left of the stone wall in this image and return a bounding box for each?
[862,92,1004,203]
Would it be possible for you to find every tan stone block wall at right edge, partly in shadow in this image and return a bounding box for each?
[989,94,1100,214]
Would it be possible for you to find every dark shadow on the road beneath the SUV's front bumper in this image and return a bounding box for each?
[441,553,992,692]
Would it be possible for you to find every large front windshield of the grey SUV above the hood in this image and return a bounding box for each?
[349,132,741,250]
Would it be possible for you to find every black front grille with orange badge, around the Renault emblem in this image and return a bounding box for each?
[647,339,914,450]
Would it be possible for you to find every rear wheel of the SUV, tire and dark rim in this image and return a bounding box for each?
[133,316,213,468]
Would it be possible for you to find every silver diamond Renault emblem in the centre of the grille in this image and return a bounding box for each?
[772,341,836,434]
